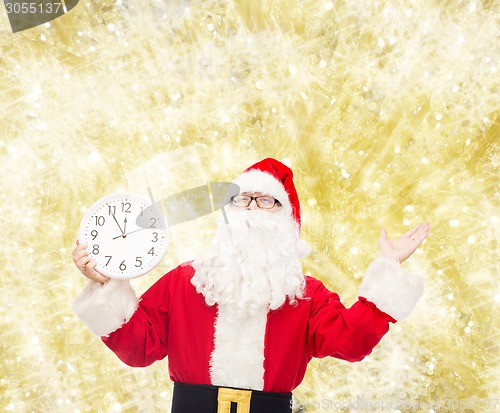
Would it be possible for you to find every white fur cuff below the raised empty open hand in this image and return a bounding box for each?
[359,258,424,321]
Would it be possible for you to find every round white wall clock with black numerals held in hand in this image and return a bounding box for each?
[78,193,168,279]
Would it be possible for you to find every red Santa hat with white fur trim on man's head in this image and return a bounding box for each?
[234,158,300,228]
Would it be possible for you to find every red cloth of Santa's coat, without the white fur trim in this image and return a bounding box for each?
[102,264,396,393]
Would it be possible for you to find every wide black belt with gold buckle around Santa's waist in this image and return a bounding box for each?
[172,383,292,413]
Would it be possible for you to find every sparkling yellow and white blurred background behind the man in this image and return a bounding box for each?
[0,0,500,413]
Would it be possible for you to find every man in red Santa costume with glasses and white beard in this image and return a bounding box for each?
[73,158,429,413]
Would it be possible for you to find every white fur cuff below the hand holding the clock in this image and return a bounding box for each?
[73,279,139,337]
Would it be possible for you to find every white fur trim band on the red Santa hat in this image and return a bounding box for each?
[234,169,292,214]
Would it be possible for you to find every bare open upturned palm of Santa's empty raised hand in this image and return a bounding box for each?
[378,222,430,262]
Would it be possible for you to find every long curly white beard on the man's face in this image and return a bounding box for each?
[191,205,310,318]
